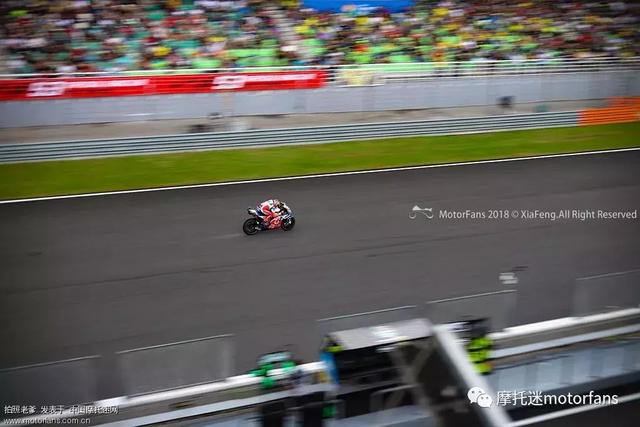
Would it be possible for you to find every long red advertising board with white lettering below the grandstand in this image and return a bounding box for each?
[0,70,326,101]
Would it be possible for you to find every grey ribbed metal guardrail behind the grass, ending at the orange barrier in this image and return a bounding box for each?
[0,111,579,163]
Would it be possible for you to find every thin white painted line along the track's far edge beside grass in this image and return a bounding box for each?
[0,147,640,204]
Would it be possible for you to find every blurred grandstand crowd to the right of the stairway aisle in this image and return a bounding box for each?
[289,0,640,64]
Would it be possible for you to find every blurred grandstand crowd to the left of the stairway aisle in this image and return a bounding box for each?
[0,0,287,73]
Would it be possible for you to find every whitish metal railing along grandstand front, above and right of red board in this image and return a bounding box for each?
[0,57,640,86]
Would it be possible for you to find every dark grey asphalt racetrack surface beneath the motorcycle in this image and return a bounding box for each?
[0,151,640,394]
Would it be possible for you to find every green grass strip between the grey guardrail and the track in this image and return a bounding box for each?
[0,123,640,199]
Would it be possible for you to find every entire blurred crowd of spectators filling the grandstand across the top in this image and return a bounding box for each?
[0,0,640,73]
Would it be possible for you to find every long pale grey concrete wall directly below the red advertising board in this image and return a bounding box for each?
[0,71,640,127]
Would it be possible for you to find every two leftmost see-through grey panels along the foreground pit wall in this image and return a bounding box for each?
[0,334,236,412]
